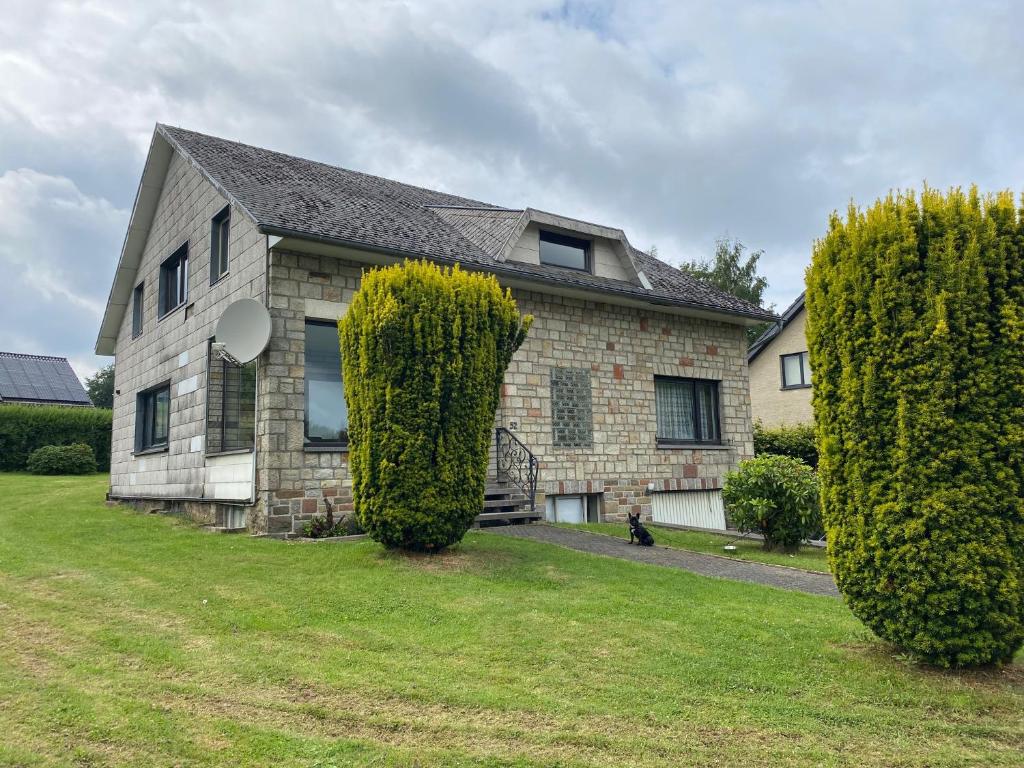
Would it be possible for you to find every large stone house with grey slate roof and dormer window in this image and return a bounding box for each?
[96,125,774,535]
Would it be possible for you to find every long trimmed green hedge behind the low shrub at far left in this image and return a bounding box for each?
[0,406,112,472]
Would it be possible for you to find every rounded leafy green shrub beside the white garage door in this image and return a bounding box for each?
[722,455,821,552]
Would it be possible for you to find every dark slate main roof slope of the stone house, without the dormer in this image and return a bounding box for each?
[157,125,775,319]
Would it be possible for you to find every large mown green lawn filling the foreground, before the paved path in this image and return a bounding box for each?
[0,475,1024,768]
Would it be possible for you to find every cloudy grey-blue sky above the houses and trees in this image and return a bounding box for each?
[0,0,1024,377]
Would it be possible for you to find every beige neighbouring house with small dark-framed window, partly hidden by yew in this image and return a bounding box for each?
[746,294,814,427]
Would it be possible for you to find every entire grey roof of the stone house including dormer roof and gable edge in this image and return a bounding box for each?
[96,124,775,354]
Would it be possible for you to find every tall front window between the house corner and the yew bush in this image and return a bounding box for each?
[305,321,348,445]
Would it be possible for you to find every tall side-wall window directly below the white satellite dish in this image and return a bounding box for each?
[206,349,256,454]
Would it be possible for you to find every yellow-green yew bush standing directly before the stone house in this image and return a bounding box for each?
[339,262,532,550]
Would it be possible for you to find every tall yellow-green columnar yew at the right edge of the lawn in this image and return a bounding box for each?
[807,188,1024,667]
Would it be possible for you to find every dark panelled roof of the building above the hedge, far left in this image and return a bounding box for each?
[0,352,92,408]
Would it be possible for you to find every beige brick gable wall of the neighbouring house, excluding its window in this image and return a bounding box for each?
[750,309,814,427]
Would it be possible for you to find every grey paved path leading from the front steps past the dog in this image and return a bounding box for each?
[484,522,839,597]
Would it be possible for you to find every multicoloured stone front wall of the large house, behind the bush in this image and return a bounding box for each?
[257,251,753,534]
